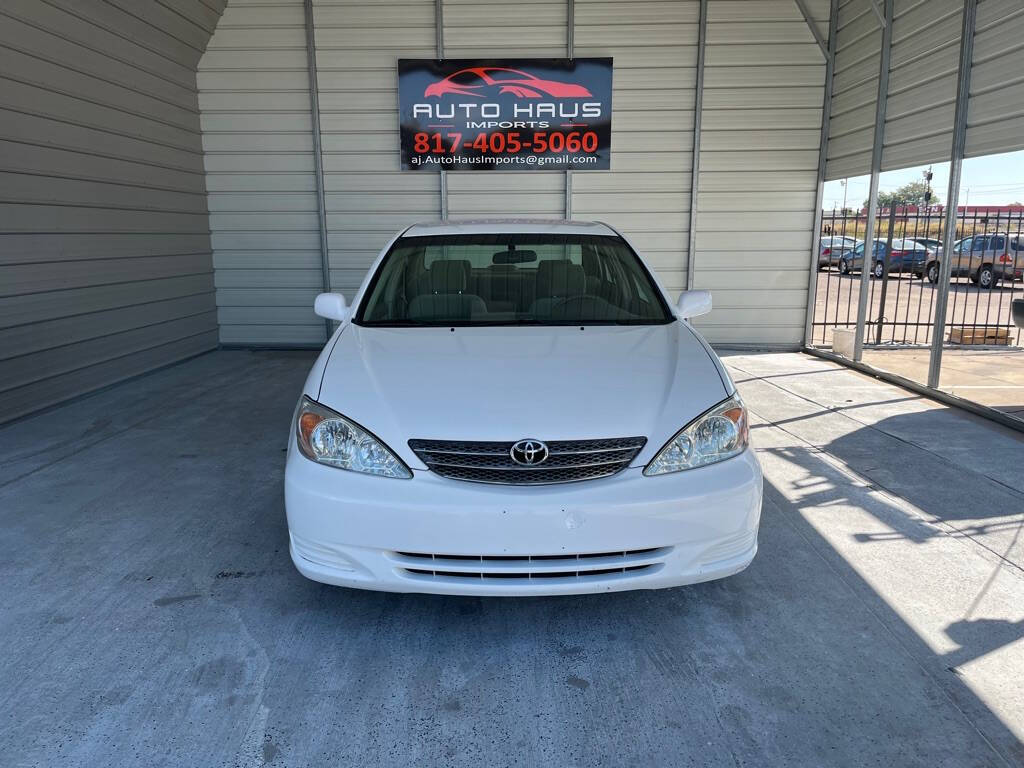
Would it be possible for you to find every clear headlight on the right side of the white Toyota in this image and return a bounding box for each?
[643,394,749,477]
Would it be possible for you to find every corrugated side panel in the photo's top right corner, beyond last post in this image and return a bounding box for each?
[965,0,1024,158]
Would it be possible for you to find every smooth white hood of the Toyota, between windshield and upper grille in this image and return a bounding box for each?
[310,322,728,469]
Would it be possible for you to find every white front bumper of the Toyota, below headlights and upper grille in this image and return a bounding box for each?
[285,445,762,595]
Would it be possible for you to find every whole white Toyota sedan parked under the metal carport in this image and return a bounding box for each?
[285,220,762,595]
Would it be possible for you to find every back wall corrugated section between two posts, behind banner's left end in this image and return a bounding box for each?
[313,0,440,307]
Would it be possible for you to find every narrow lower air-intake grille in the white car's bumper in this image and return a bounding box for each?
[392,547,672,583]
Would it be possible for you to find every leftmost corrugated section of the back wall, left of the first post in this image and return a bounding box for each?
[198,0,325,344]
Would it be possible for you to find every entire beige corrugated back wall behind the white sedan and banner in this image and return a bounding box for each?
[200,0,802,343]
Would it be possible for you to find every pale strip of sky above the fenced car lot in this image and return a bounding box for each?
[822,151,1024,211]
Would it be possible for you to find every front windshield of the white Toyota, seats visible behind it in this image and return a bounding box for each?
[355,233,673,327]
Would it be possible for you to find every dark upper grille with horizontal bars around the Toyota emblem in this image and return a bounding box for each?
[409,437,647,485]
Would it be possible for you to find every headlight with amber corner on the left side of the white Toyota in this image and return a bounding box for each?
[295,395,413,478]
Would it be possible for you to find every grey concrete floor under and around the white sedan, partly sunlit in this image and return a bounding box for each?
[0,352,1024,768]
